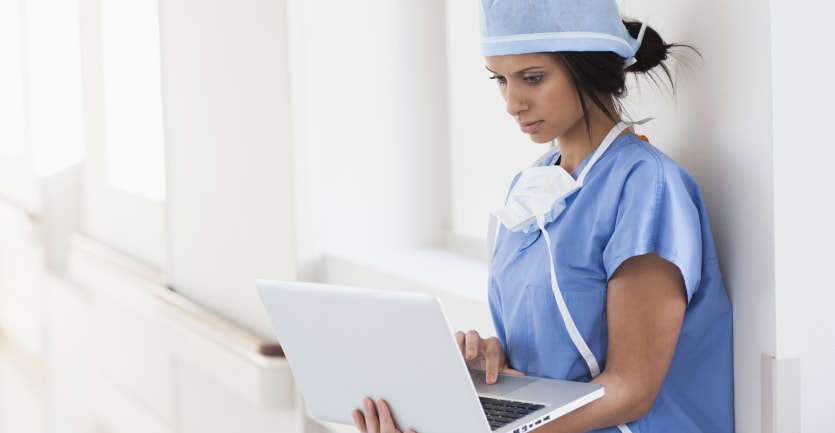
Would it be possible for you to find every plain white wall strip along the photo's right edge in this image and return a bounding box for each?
[771,0,835,432]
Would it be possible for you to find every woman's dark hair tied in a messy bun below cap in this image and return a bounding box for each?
[553,21,699,133]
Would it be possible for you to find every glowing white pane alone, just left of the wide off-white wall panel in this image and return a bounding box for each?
[101,0,165,200]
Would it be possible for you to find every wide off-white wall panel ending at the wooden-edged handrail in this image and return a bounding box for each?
[160,0,296,338]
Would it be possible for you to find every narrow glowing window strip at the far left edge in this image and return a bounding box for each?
[0,0,24,155]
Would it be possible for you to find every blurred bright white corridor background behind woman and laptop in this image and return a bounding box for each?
[0,0,835,433]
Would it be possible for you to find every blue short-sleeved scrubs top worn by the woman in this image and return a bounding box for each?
[489,134,733,433]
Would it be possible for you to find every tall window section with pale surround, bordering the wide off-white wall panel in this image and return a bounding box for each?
[80,0,166,270]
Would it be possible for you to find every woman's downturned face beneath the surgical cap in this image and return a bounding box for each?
[486,53,587,143]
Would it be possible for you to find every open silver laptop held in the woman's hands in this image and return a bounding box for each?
[256,279,603,433]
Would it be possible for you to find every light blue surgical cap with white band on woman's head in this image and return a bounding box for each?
[481,0,644,63]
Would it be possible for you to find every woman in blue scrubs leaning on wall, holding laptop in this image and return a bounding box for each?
[354,0,733,433]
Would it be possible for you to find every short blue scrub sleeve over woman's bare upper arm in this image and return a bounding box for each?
[603,154,702,302]
